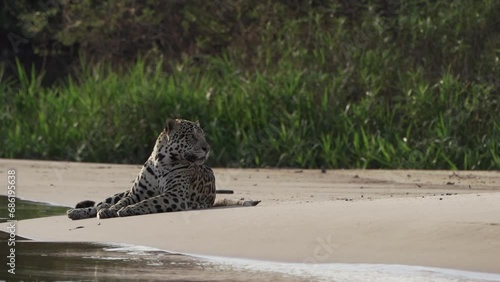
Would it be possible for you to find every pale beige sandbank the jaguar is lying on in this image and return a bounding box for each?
[0,159,500,273]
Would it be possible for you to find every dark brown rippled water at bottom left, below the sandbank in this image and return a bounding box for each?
[0,240,298,281]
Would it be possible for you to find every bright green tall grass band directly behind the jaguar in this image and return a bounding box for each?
[0,56,500,169]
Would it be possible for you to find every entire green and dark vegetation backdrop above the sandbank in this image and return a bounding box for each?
[0,0,500,169]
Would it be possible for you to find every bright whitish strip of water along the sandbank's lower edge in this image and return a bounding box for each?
[101,244,500,282]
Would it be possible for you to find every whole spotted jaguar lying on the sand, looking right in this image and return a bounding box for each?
[67,119,260,220]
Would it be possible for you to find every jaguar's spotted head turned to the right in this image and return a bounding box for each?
[164,119,210,165]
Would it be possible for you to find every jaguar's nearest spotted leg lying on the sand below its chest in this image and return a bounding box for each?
[118,192,192,217]
